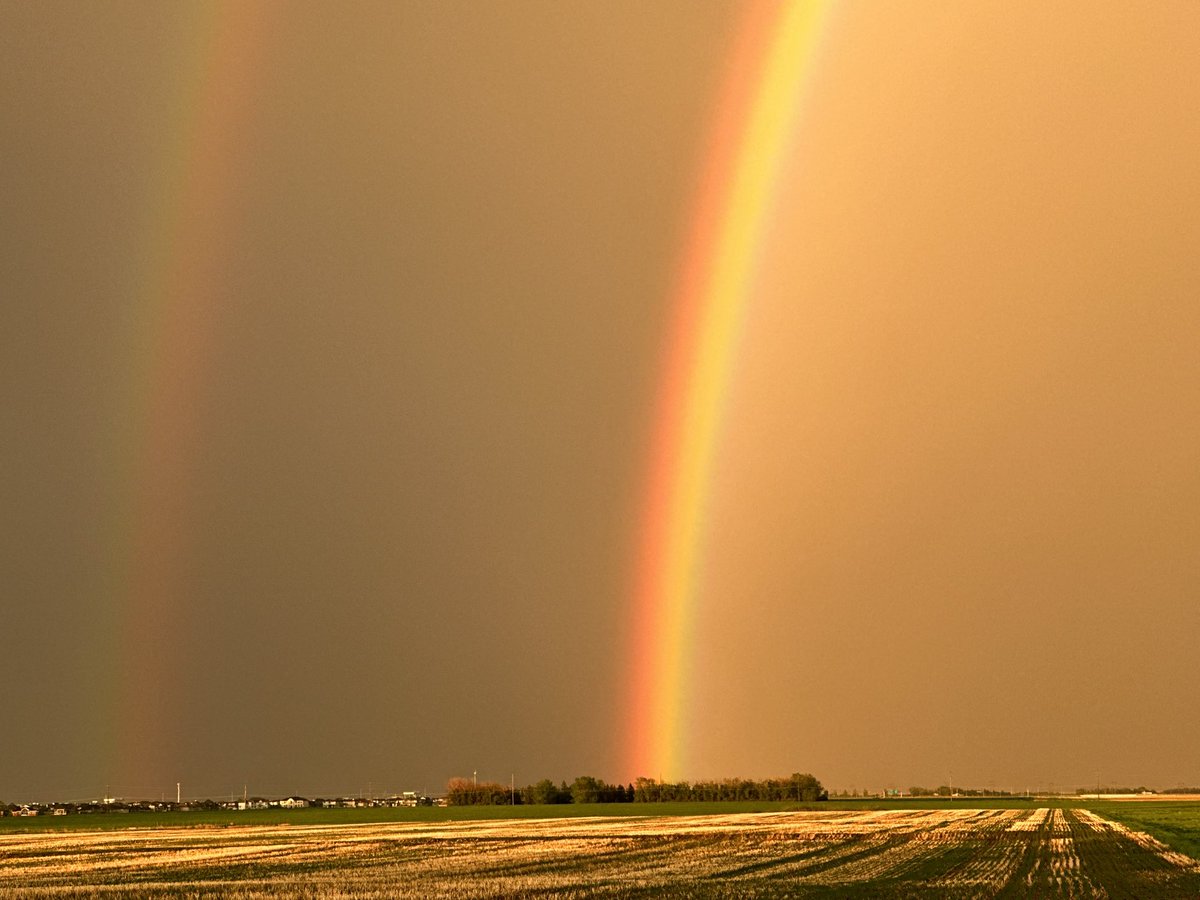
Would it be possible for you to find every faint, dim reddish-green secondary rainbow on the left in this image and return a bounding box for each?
[97,0,275,792]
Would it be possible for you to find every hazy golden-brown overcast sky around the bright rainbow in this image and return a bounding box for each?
[0,0,1200,802]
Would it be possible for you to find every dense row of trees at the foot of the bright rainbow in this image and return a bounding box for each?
[446,772,829,806]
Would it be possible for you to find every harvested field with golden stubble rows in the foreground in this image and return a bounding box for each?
[0,809,1200,900]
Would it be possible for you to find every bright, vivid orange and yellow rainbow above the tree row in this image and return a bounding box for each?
[626,0,832,779]
